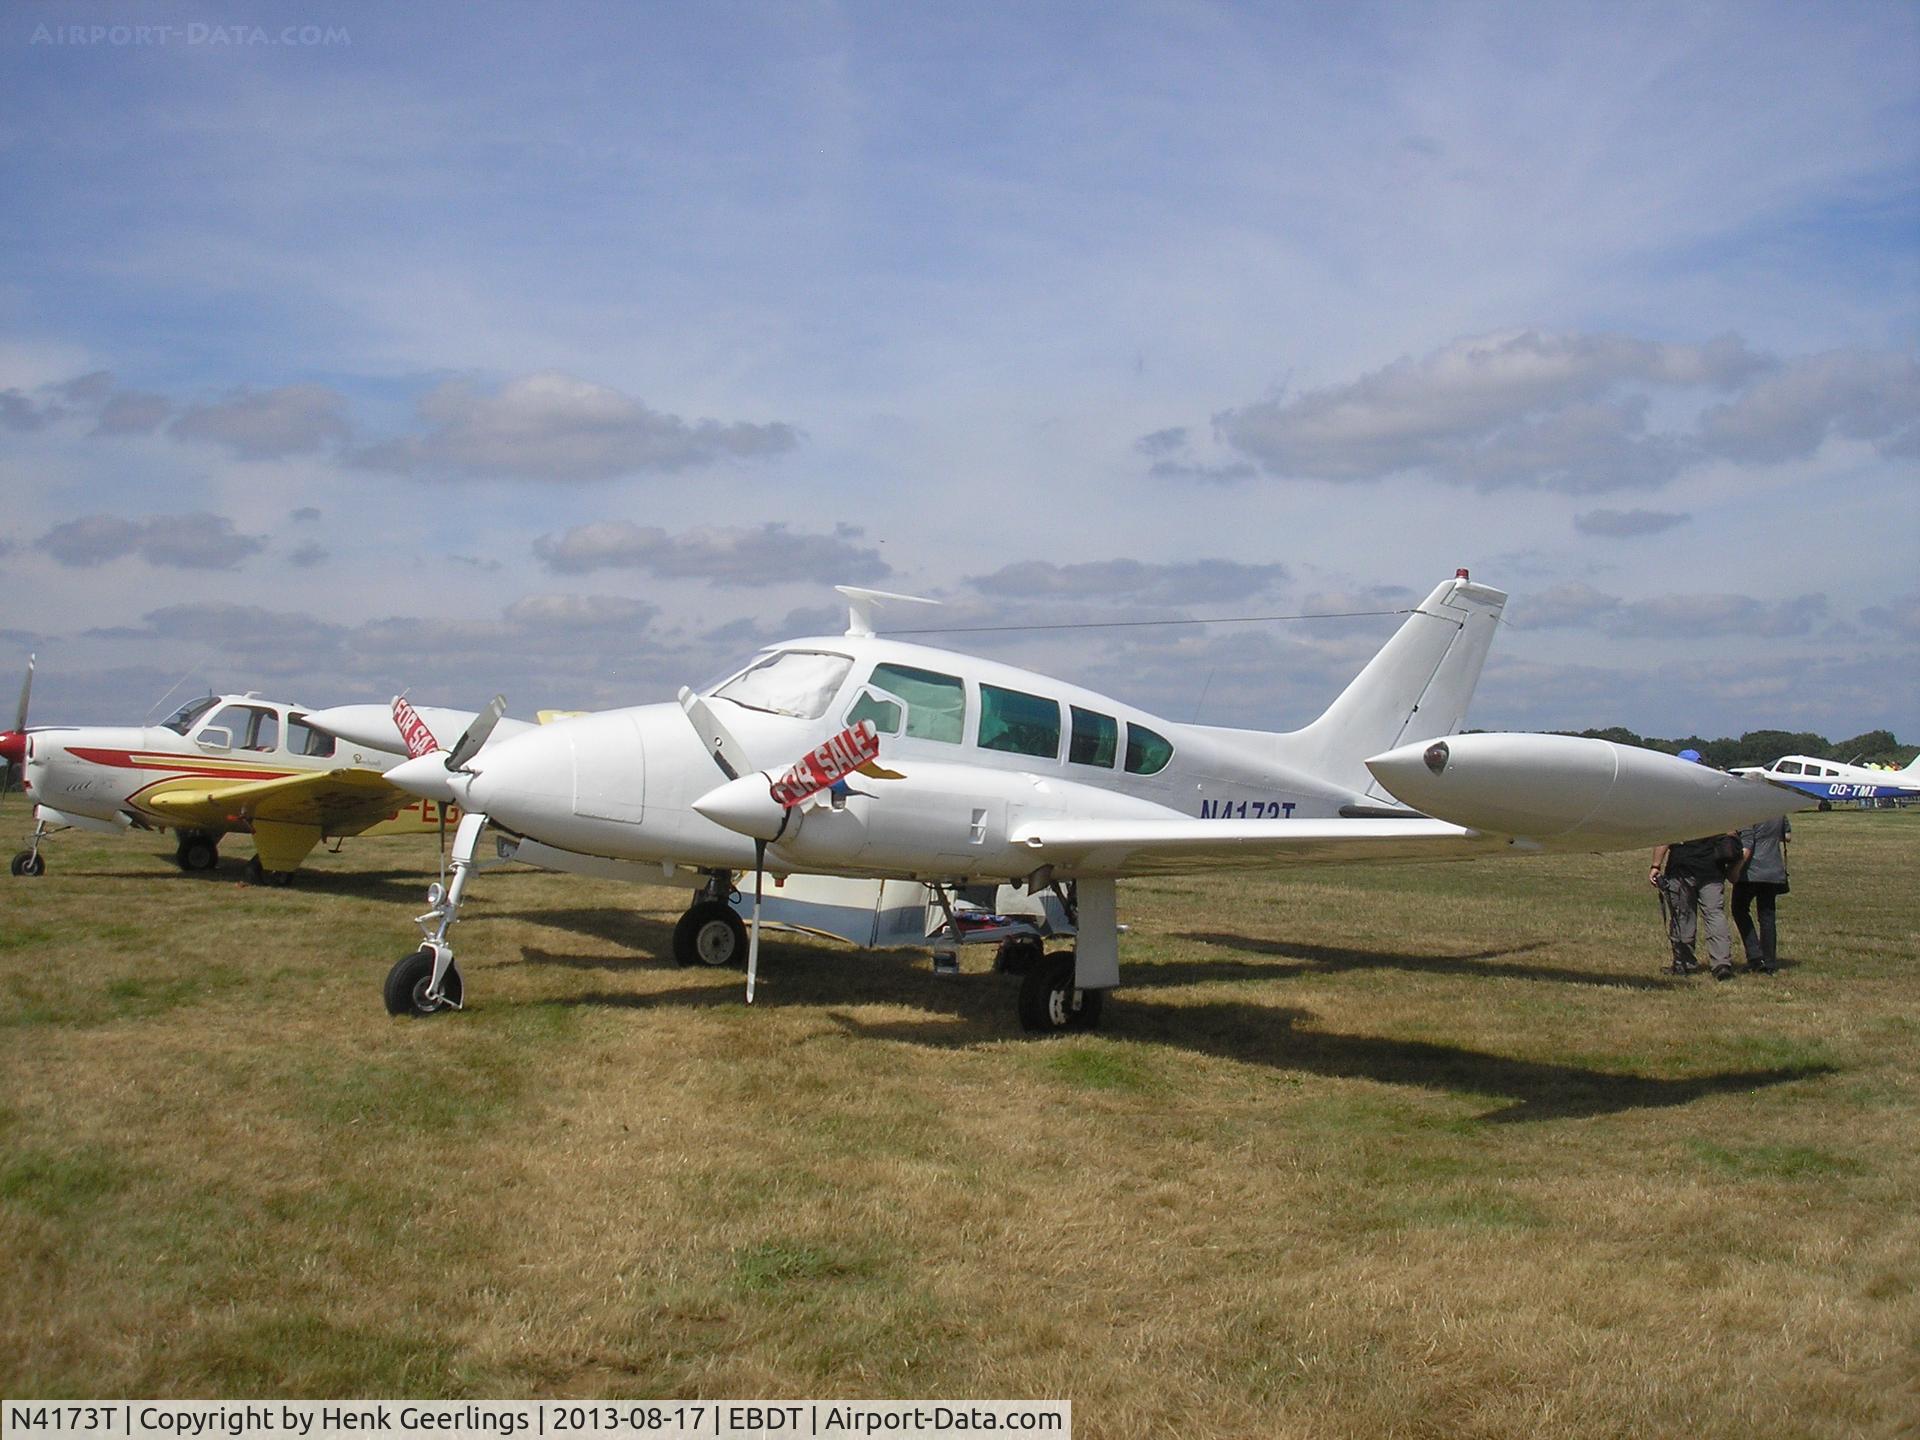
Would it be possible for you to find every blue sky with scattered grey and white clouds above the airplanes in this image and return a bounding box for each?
[0,0,1920,739]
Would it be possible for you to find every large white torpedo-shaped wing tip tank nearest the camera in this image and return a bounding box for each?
[1367,733,1812,849]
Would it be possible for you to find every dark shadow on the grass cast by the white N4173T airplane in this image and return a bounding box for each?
[522,936,1834,1123]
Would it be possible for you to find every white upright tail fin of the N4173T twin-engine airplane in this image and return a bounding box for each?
[1277,570,1507,804]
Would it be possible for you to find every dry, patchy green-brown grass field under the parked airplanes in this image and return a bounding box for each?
[0,810,1920,1440]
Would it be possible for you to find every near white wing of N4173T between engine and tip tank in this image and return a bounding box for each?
[1014,820,1513,876]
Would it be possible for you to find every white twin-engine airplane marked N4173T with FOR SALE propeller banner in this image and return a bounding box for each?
[386,570,1811,1031]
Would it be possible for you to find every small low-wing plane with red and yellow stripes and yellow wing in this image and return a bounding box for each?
[0,660,528,885]
